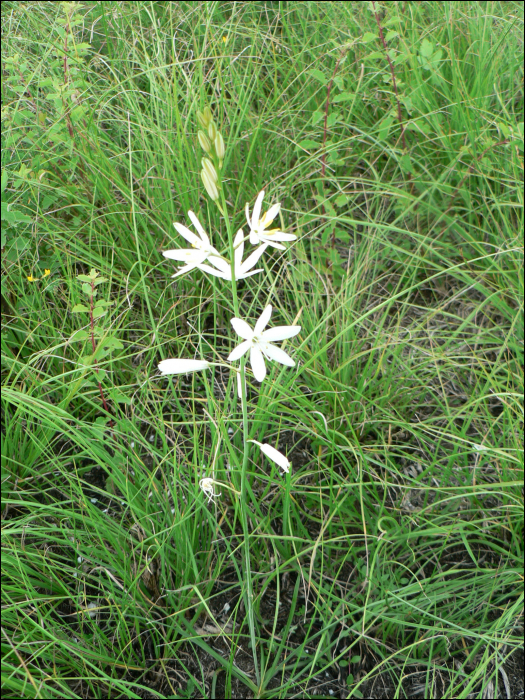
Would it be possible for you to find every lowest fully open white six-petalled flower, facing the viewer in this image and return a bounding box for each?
[228,304,301,382]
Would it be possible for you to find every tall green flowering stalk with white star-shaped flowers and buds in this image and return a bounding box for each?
[159,107,301,683]
